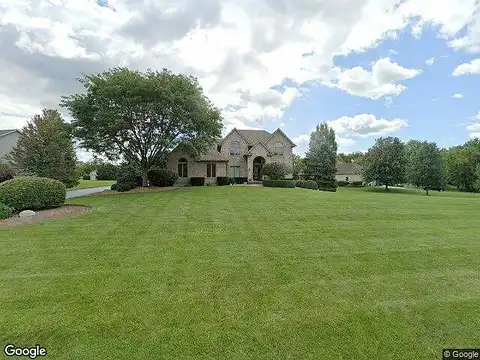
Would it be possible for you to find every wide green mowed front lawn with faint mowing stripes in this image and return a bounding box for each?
[0,187,480,360]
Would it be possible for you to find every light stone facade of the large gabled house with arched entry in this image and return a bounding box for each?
[167,129,296,184]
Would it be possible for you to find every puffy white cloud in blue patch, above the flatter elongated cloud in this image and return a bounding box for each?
[324,57,422,100]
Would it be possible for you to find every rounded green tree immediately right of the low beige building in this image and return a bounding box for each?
[363,137,407,190]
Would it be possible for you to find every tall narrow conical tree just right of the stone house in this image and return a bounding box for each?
[305,123,337,185]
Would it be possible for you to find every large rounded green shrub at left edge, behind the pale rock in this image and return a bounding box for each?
[0,176,67,212]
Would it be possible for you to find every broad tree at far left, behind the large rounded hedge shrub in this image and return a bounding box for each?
[10,109,78,187]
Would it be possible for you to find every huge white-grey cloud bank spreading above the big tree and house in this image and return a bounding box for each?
[0,0,480,136]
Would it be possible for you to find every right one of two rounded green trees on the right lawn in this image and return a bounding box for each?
[407,141,445,195]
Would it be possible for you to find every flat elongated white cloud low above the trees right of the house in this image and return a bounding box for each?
[328,114,408,137]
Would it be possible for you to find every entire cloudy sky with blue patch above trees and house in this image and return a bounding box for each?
[0,0,480,159]
